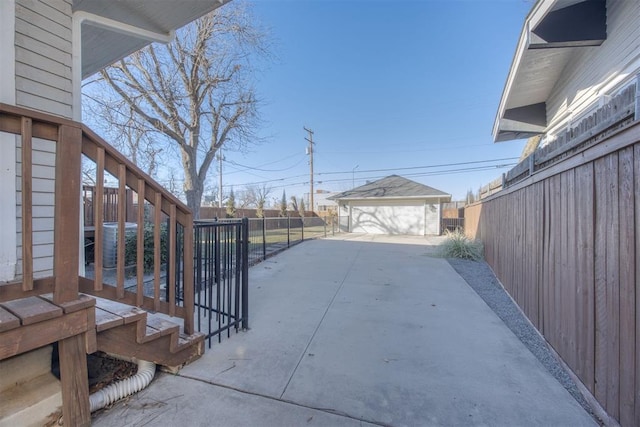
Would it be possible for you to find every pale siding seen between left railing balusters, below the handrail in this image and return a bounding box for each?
[16,138,56,278]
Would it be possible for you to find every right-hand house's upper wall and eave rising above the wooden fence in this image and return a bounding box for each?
[493,0,640,150]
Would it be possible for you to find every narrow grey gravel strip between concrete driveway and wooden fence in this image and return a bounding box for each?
[447,258,597,419]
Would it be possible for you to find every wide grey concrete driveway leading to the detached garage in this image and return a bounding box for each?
[94,235,597,426]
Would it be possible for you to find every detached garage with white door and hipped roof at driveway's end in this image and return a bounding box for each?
[330,175,451,236]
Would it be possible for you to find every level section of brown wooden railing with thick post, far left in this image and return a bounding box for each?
[0,104,82,303]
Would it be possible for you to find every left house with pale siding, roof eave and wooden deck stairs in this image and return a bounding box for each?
[0,0,230,425]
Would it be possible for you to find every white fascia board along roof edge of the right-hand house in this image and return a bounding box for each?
[492,0,557,142]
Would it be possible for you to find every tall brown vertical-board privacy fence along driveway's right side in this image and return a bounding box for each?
[465,123,640,427]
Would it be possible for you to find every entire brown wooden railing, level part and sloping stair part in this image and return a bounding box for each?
[0,104,194,334]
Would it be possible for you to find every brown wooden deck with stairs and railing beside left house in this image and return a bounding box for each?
[0,103,204,425]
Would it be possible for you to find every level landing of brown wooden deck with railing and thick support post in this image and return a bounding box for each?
[0,104,91,425]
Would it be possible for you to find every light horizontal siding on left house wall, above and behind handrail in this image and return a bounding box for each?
[10,0,73,279]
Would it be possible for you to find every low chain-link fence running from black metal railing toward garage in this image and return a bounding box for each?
[249,217,324,265]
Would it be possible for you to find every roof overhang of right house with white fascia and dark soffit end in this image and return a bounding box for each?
[493,0,607,142]
